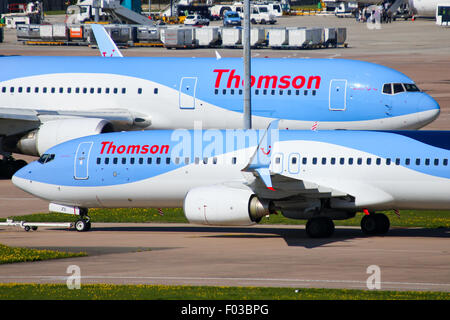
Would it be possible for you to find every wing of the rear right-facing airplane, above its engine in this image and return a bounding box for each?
[0,107,151,136]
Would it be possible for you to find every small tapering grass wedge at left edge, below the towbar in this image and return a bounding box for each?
[0,244,87,264]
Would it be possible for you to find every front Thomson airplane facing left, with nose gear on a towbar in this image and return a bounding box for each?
[12,121,450,237]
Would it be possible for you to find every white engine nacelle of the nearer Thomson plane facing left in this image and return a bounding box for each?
[183,186,274,226]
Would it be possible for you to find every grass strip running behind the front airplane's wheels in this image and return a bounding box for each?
[4,208,450,229]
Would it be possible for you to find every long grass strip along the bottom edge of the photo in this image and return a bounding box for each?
[0,283,450,300]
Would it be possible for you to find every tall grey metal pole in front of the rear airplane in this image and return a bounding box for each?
[243,0,252,129]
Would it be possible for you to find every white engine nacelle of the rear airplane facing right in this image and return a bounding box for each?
[16,118,114,156]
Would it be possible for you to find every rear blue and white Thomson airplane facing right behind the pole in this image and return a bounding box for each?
[0,53,440,170]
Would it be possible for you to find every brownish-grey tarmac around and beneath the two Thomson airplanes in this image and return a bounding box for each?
[0,16,450,292]
